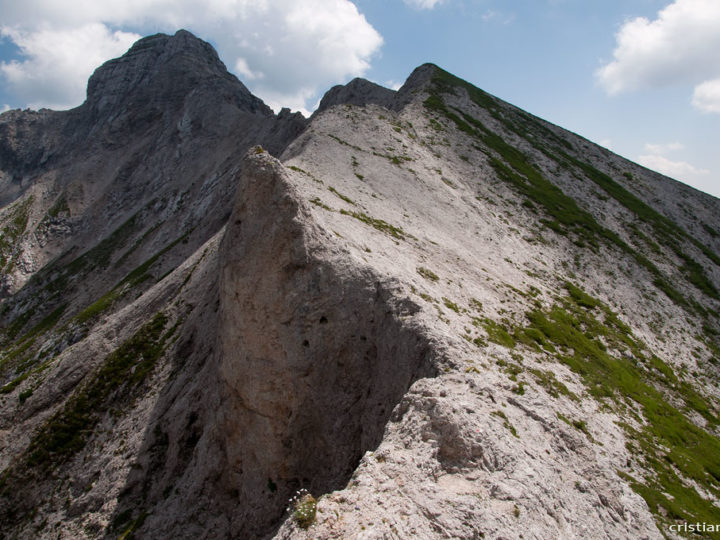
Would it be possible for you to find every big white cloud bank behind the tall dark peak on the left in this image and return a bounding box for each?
[0,0,382,110]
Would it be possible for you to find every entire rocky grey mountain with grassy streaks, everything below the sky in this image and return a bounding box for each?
[0,30,720,540]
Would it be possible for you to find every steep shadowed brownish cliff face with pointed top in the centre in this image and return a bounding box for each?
[218,152,437,533]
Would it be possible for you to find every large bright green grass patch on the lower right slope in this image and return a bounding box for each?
[516,284,720,523]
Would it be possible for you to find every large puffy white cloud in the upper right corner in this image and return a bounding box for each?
[596,0,720,105]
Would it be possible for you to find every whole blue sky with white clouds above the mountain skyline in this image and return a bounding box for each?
[0,0,720,196]
